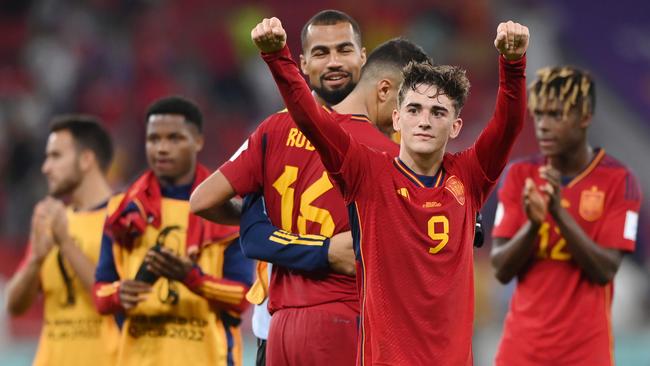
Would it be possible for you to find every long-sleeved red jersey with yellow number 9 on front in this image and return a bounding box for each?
[263,47,526,366]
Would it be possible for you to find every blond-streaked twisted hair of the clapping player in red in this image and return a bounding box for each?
[528,66,596,117]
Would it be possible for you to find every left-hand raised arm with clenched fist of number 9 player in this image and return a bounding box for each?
[251,18,350,172]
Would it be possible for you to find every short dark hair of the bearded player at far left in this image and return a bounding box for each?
[50,114,113,172]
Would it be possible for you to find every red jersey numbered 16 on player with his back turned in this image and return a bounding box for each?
[219,107,398,313]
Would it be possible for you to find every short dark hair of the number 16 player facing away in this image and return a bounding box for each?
[361,38,433,79]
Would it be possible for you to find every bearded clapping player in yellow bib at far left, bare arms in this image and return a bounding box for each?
[7,115,118,366]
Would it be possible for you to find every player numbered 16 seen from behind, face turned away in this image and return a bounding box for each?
[193,16,428,365]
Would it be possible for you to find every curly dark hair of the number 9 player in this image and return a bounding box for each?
[397,62,470,116]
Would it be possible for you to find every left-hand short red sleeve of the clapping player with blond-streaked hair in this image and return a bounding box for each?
[492,165,527,239]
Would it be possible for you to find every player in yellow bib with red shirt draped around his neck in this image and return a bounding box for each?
[94,97,253,365]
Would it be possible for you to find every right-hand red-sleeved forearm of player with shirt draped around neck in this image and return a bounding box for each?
[183,266,250,313]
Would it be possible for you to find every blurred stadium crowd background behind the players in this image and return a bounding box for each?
[0,0,650,366]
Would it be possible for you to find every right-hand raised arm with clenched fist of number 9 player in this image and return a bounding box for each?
[475,21,529,181]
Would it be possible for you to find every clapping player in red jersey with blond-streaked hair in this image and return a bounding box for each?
[492,66,641,366]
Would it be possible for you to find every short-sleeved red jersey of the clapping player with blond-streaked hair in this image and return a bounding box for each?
[492,149,641,366]
